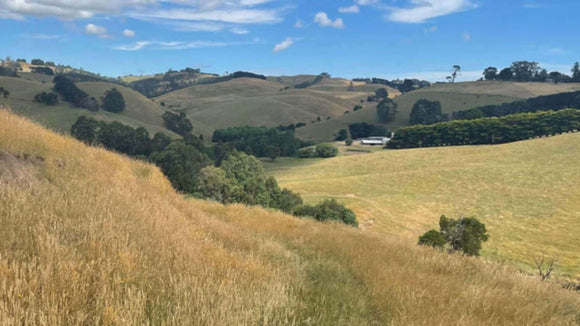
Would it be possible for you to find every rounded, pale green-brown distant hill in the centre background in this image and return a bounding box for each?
[156,78,386,134]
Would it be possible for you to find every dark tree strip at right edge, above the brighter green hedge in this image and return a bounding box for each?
[452,92,580,120]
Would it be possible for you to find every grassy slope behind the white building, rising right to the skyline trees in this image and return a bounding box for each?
[297,81,580,142]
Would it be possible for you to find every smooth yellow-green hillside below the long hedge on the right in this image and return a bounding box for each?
[265,133,580,279]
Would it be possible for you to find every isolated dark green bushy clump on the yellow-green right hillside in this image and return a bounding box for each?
[419,215,489,256]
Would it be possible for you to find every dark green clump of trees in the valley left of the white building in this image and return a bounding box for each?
[212,126,307,157]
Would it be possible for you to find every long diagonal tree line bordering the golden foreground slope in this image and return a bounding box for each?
[71,116,357,226]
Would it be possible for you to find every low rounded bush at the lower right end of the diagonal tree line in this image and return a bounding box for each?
[294,199,358,227]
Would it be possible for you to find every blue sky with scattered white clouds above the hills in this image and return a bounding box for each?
[0,0,580,81]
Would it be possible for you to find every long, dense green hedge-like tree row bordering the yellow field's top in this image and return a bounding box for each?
[387,109,580,149]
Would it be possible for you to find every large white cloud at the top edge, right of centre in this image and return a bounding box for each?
[387,0,477,23]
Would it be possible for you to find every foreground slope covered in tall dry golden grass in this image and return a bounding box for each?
[0,111,580,325]
